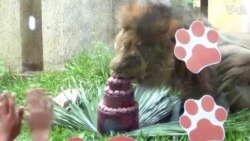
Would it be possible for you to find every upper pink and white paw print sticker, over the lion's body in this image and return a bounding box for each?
[174,21,221,73]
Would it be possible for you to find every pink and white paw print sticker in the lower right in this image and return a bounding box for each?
[179,95,227,141]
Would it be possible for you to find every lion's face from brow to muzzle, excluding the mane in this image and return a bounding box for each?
[111,30,146,78]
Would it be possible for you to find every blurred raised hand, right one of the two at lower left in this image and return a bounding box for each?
[27,89,53,141]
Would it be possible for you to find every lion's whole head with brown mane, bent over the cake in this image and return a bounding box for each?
[111,3,178,85]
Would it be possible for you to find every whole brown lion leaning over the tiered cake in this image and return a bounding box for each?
[110,3,250,112]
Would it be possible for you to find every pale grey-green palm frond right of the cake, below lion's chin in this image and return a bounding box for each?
[135,86,180,127]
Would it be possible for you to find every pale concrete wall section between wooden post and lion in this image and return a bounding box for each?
[42,0,116,70]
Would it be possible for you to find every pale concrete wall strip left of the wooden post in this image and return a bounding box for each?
[0,0,22,71]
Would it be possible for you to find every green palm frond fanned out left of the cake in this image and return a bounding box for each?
[54,81,101,132]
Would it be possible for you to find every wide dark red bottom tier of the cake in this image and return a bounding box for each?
[97,104,139,134]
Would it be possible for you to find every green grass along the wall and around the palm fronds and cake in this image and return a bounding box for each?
[0,42,250,141]
